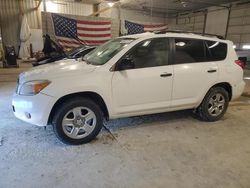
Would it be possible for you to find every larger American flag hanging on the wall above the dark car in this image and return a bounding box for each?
[51,14,111,48]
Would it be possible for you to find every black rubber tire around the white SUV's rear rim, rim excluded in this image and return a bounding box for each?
[195,87,229,121]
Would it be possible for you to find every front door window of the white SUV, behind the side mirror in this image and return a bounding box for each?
[123,38,169,68]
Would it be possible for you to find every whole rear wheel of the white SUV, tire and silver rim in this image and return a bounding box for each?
[196,87,229,121]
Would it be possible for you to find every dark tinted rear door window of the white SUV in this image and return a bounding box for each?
[175,38,206,64]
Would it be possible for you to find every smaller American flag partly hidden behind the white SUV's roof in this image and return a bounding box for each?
[125,20,168,35]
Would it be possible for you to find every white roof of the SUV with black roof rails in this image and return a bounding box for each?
[120,32,227,42]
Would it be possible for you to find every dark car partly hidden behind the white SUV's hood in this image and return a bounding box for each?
[33,46,96,66]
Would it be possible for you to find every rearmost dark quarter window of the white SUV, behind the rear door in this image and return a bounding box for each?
[205,41,227,61]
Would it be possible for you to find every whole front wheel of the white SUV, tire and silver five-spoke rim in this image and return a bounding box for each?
[53,98,103,145]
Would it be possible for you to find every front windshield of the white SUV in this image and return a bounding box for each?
[84,38,134,65]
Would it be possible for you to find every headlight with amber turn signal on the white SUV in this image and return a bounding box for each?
[18,80,50,95]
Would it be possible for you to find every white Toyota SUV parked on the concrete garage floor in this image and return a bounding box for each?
[12,32,245,144]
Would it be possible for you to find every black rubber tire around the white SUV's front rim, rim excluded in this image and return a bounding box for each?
[52,98,103,145]
